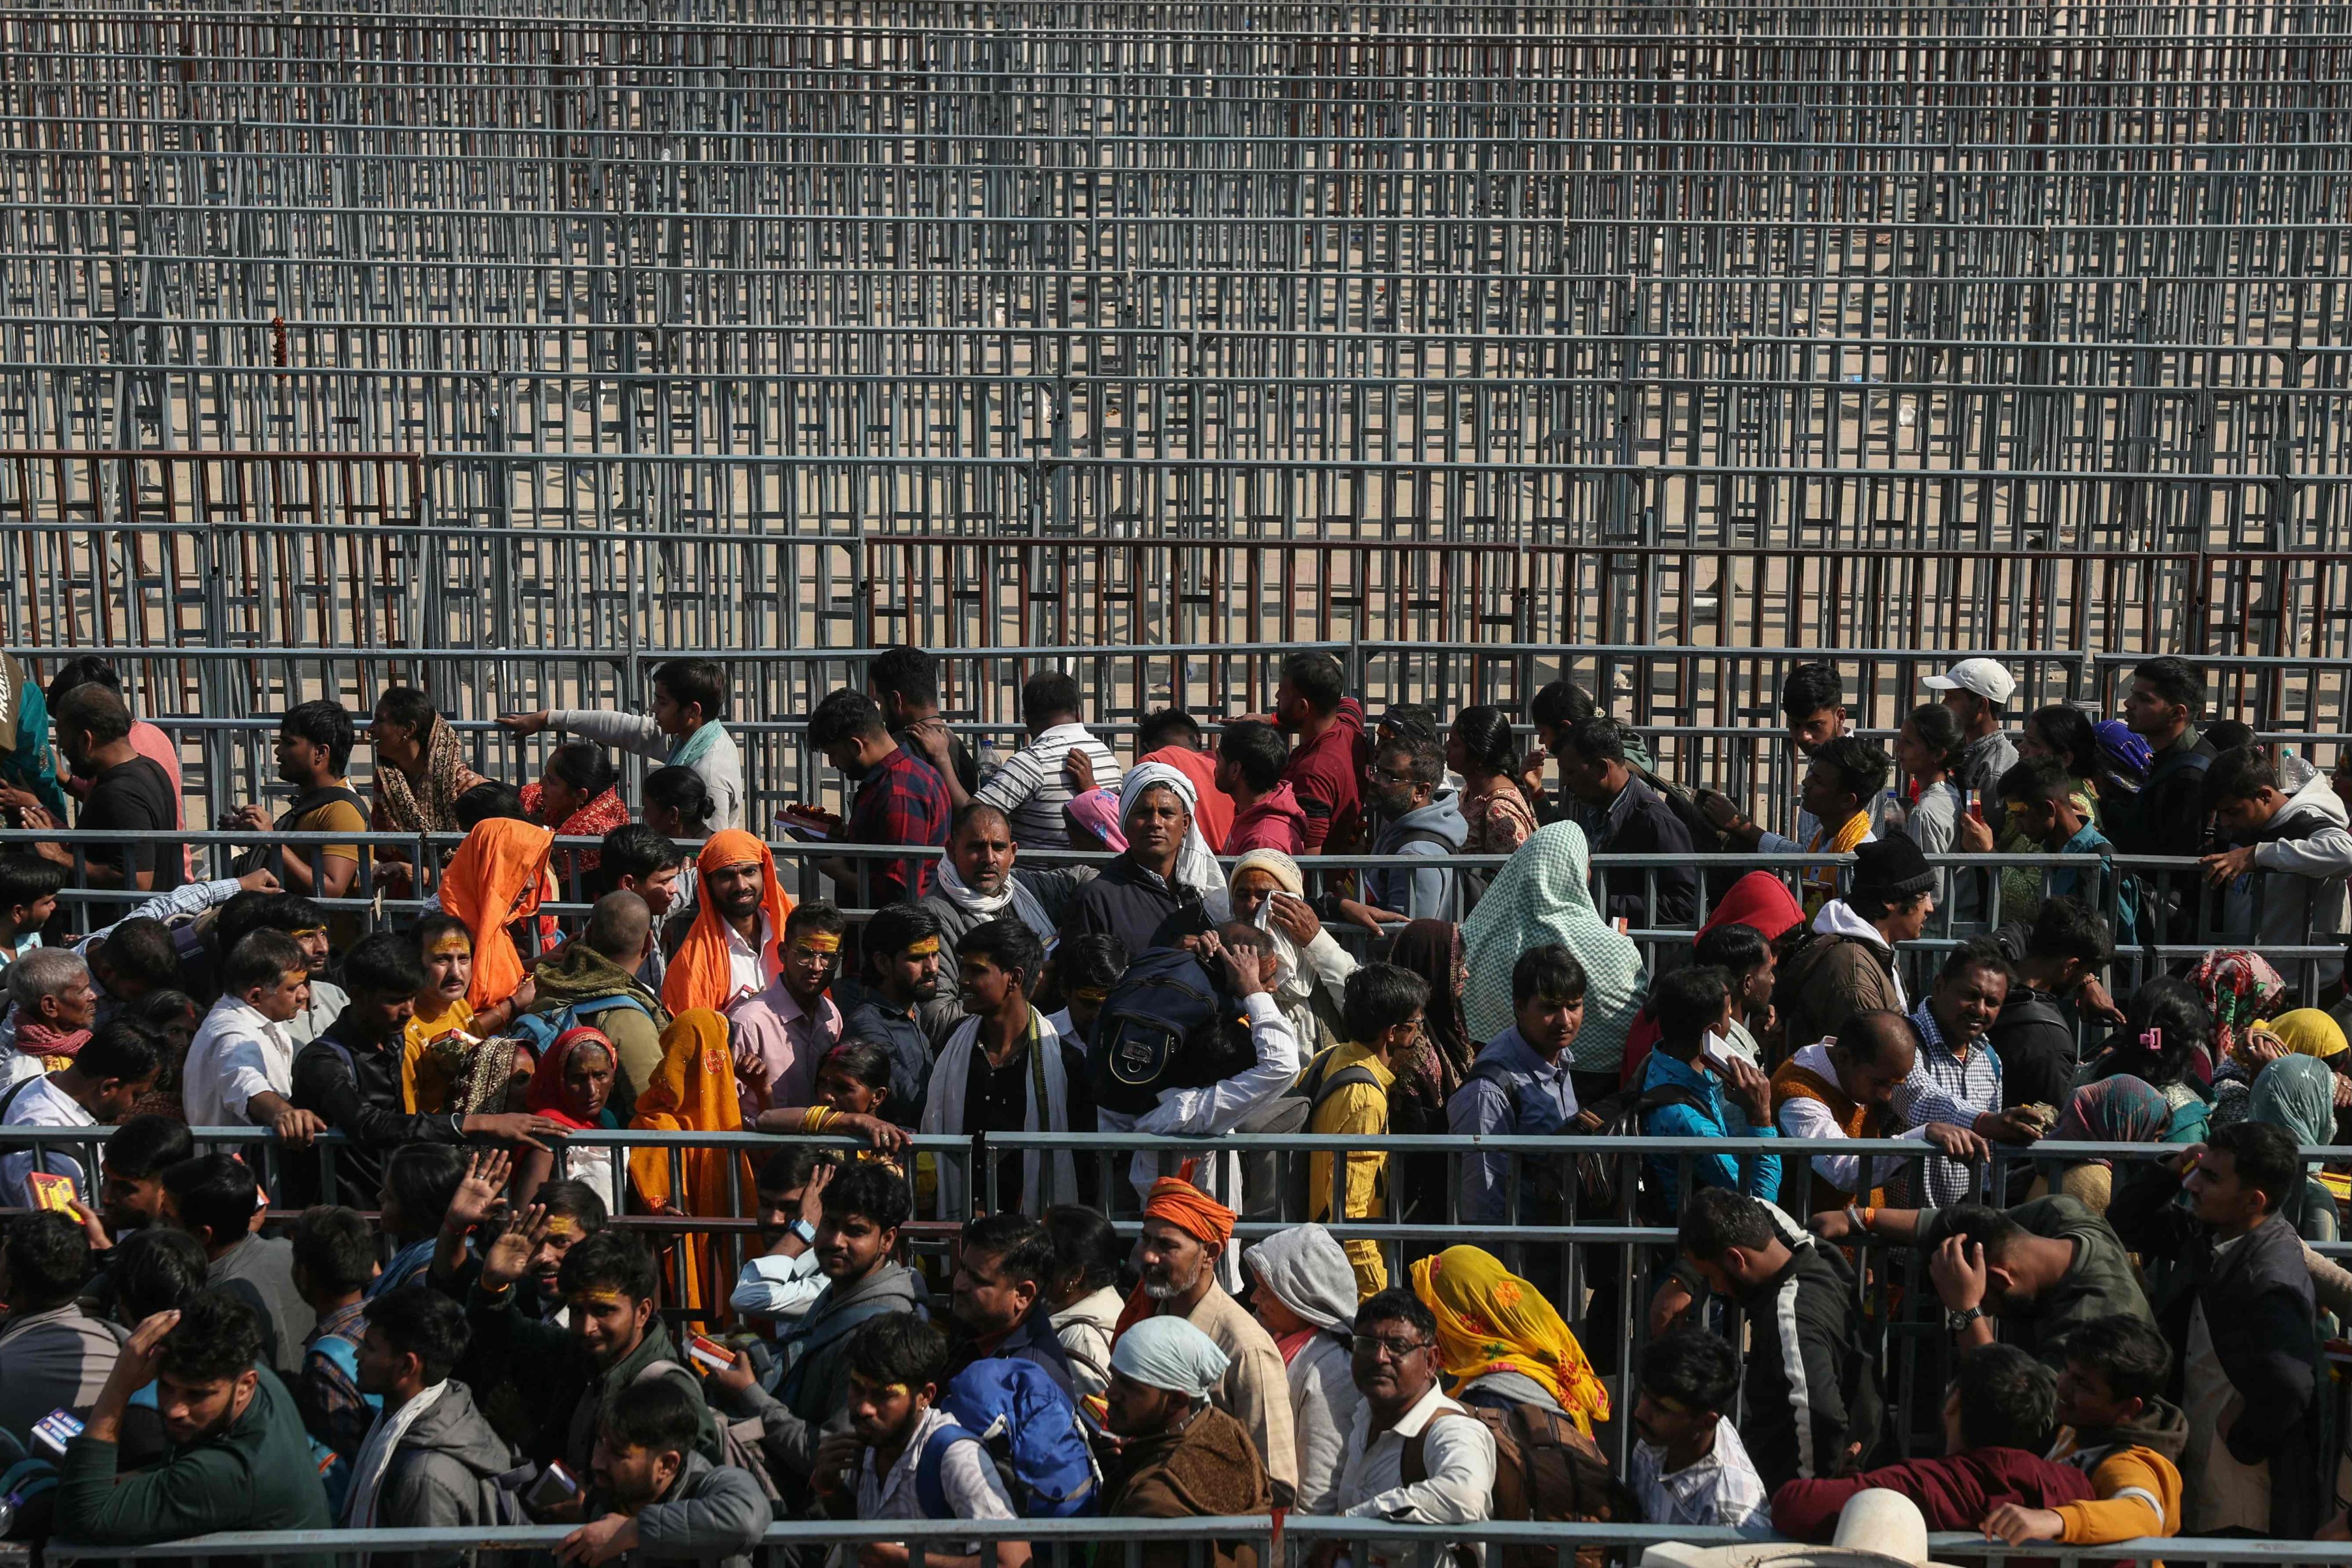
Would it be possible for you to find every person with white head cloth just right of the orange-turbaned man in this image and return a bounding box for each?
[1242,1225,1364,1514]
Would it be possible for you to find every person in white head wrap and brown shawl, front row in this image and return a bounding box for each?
[1103,1316,1275,1568]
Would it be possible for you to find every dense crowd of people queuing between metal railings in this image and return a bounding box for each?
[0,649,2352,1568]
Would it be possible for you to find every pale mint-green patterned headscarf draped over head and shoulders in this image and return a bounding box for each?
[1463,823,1649,1072]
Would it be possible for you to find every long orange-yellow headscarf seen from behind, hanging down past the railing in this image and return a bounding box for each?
[628,1009,752,1314]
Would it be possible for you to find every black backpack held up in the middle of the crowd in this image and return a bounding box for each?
[1087,947,1258,1117]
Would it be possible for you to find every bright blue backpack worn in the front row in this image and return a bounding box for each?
[915,1359,1103,1519]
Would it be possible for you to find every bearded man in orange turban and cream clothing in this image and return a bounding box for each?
[1119,1175,1298,1507]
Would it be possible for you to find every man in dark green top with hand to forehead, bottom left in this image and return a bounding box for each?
[56,1291,334,1568]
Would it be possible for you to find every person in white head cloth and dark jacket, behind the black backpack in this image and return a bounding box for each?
[1063,762,1233,955]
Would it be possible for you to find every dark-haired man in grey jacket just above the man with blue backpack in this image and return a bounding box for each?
[710,1164,929,1507]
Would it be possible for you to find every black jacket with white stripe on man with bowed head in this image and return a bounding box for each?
[1740,1241,1884,1493]
